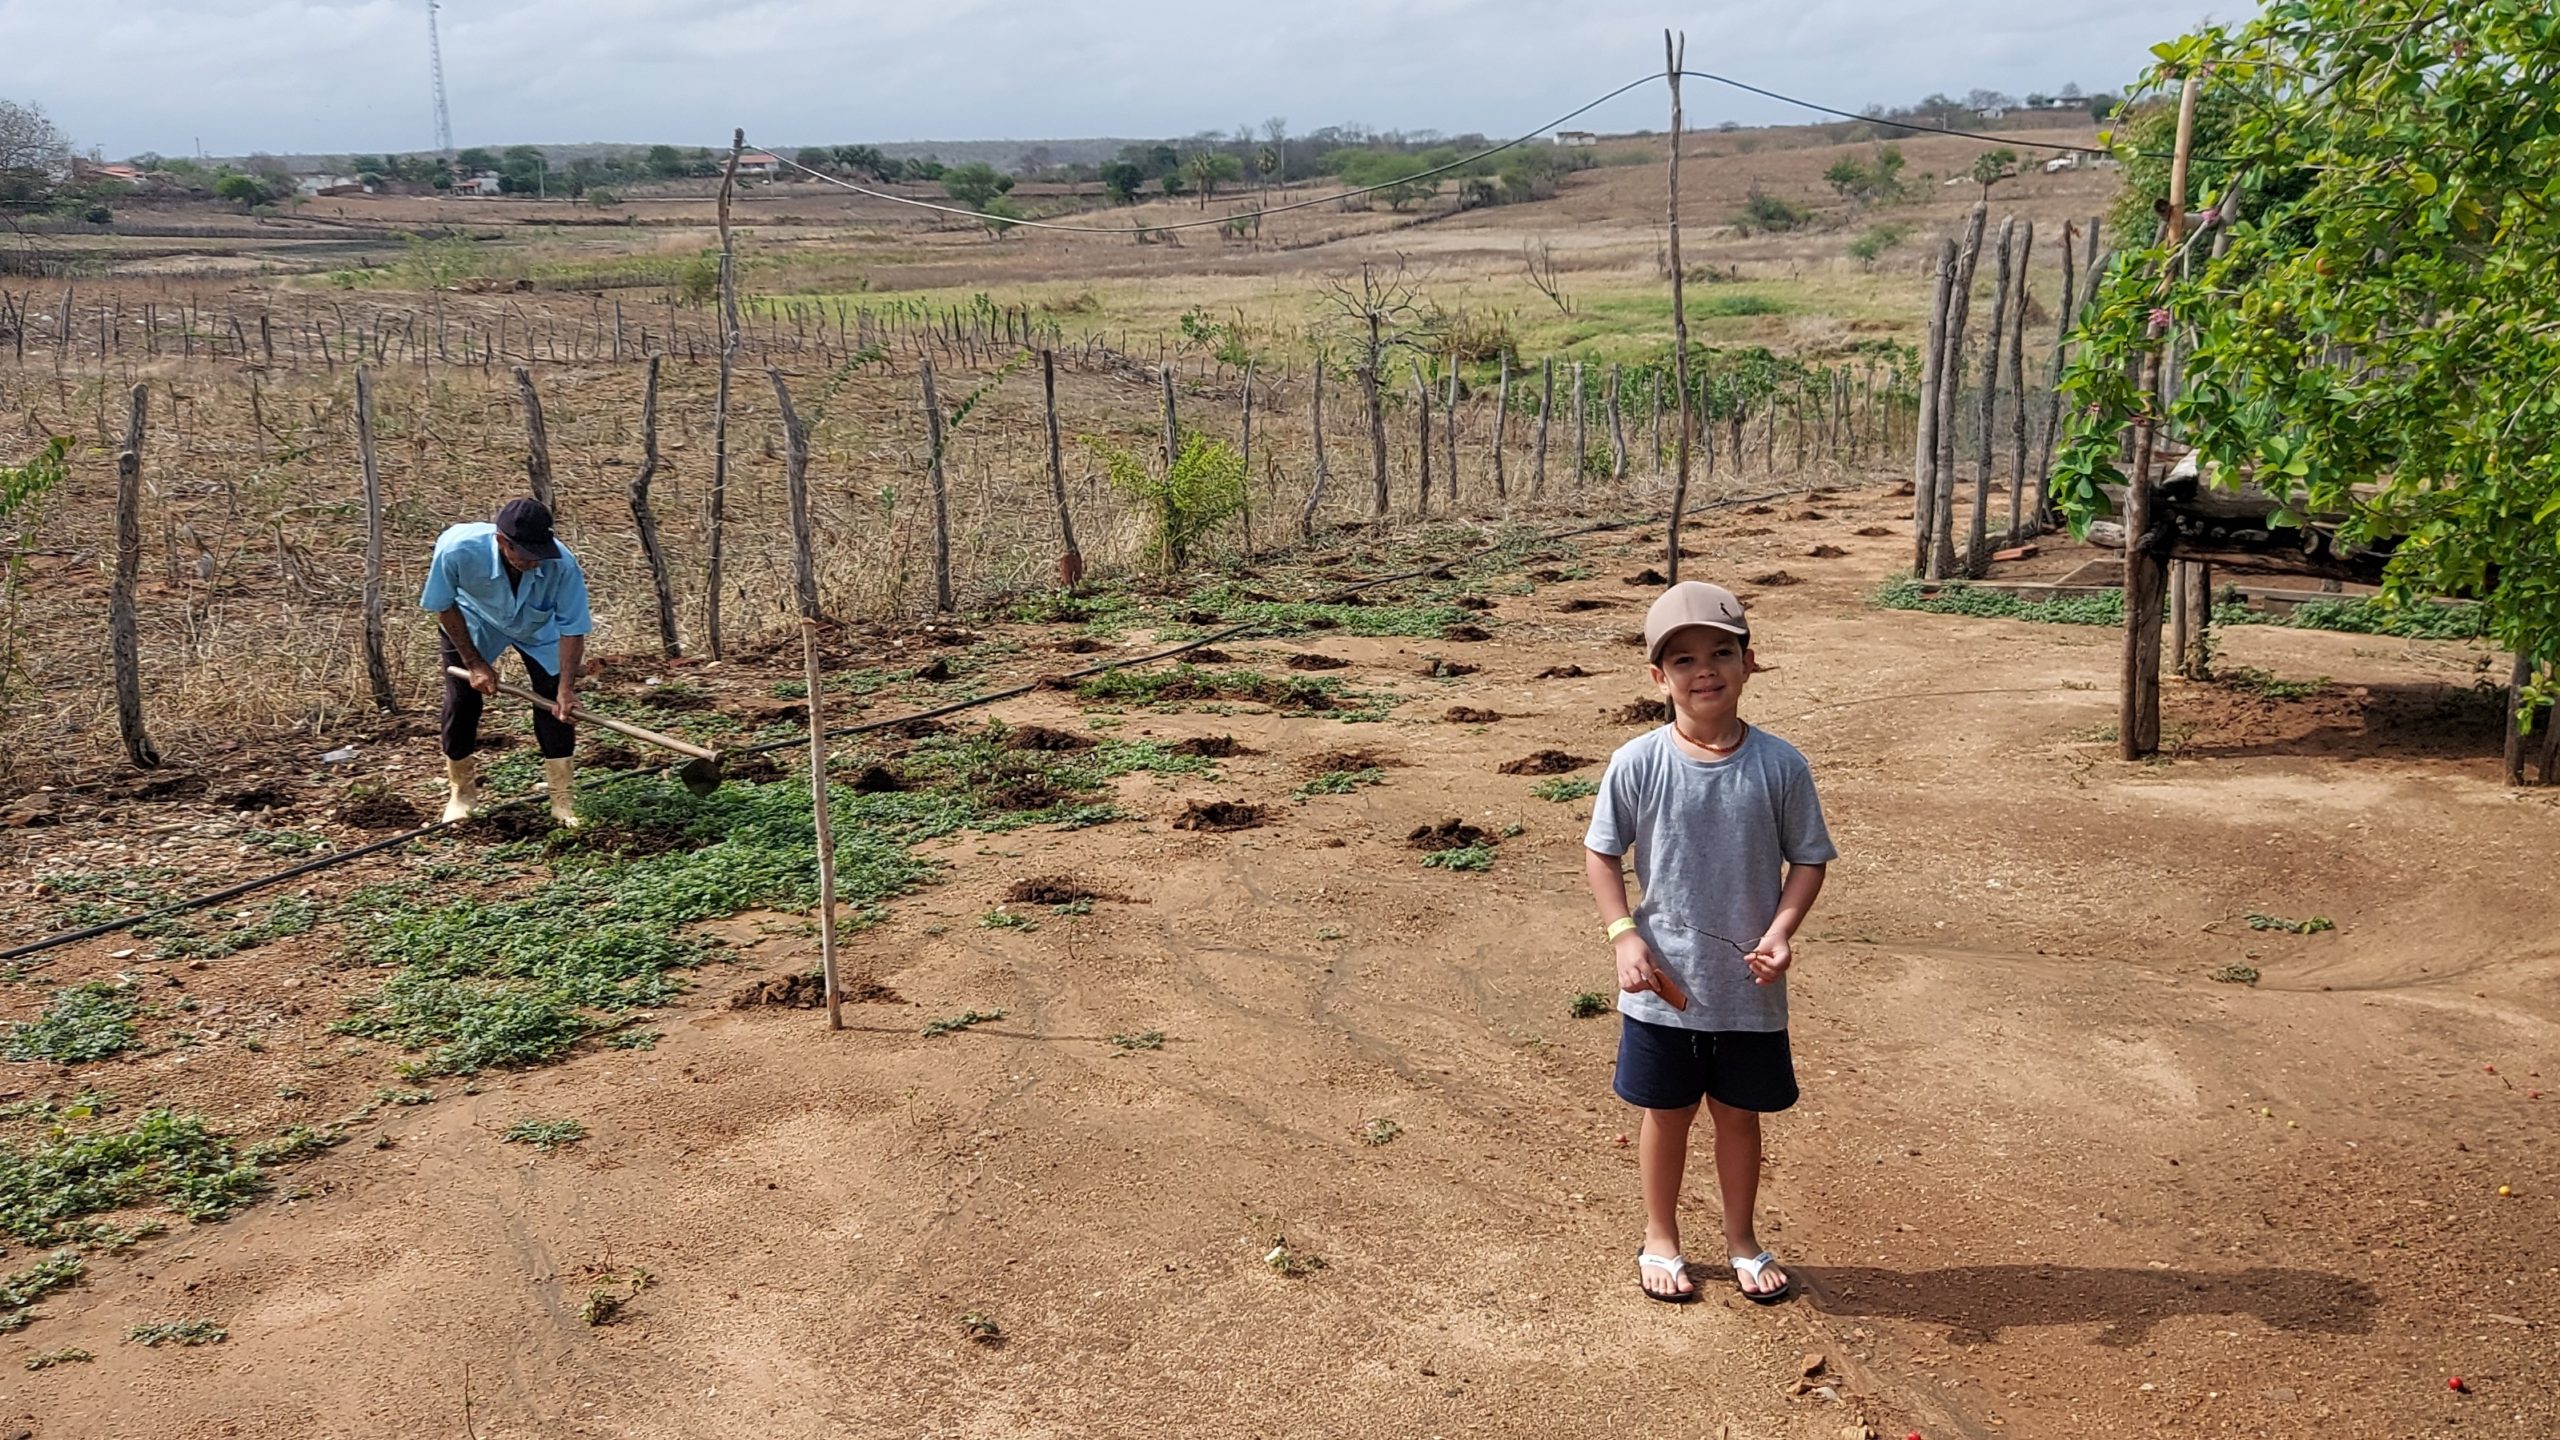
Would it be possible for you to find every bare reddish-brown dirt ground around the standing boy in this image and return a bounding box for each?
[0,484,2560,1440]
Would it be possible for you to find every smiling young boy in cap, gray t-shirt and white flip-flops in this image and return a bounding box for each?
[1582,582,1838,1304]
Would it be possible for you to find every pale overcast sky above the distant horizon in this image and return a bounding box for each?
[0,0,2245,159]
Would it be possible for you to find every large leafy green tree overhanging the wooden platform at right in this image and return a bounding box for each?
[2056,0,2560,686]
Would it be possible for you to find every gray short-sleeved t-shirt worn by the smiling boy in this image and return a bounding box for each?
[1582,725,1838,1030]
